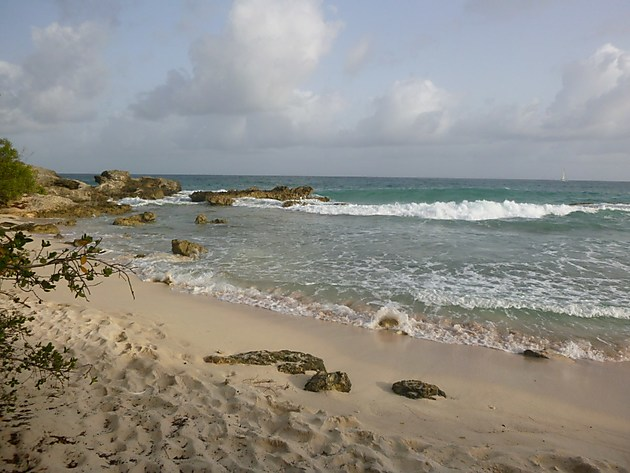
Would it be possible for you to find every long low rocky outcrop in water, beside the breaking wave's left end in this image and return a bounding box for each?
[190,186,329,206]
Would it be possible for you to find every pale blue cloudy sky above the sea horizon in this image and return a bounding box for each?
[0,0,630,181]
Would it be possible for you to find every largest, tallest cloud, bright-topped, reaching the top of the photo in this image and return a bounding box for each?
[131,0,340,119]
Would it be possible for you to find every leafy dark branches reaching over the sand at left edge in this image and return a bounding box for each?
[0,228,133,415]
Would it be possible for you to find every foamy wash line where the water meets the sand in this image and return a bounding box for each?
[126,255,627,361]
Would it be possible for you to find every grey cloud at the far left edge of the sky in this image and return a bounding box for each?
[0,22,107,132]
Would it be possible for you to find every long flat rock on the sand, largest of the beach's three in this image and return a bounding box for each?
[203,350,326,374]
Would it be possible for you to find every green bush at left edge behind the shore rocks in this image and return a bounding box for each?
[0,138,36,205]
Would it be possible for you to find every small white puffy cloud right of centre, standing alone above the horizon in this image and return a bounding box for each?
[357,79,454,144]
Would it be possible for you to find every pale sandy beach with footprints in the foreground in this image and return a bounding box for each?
[0,224,630,472]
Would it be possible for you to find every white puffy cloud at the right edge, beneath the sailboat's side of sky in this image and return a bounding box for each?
[544,44,630,137]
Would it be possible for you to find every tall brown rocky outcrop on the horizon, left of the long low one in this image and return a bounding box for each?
[94,170,182,200]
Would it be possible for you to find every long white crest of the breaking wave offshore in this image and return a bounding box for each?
[289,200,599,221]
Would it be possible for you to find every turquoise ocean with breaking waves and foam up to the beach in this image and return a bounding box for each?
[66,175,630,361]
